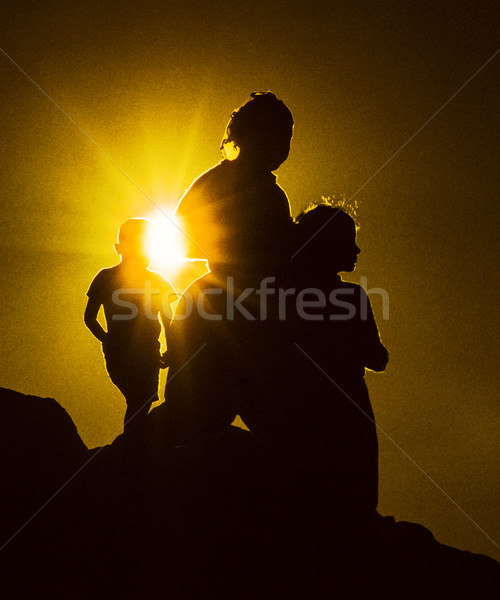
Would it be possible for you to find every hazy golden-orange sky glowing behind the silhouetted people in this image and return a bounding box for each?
[0,0,500,559]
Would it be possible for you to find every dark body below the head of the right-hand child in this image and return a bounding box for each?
[292,275,385,509]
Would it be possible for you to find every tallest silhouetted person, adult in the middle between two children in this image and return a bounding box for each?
[162,92,293,437]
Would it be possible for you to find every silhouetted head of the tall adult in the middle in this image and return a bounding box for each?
[221,92,293,171]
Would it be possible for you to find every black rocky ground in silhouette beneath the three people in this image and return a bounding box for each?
[0,389,500,600]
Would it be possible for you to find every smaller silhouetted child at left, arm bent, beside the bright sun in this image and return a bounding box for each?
[84,219,177,431]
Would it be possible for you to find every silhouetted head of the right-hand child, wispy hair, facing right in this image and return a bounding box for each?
[297,203,360,273]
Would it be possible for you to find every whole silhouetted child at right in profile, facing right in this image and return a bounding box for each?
[294,203,388,509]
